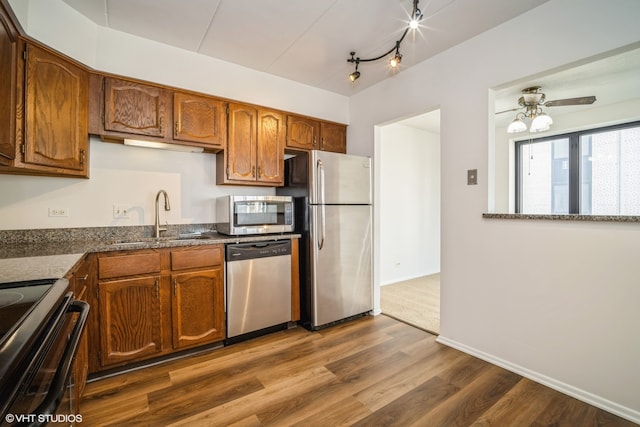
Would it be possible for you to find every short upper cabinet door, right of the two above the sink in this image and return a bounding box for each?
[173,93,227,148]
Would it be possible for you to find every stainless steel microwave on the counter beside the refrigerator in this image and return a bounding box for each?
[216,196,293,236]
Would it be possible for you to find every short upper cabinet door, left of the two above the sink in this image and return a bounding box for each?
[104,77,168,137]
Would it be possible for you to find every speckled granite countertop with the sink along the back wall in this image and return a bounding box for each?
[0,225,301,283]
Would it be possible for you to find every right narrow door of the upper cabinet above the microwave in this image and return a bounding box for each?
[257,110,285,185]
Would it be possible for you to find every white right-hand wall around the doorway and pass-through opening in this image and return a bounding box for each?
[348,0,640,422]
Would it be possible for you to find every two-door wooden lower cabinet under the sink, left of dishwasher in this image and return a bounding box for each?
[89,245,226,373]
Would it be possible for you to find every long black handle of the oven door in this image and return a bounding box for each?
[32,300,89,426]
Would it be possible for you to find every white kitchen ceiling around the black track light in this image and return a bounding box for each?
[63,0,548,96]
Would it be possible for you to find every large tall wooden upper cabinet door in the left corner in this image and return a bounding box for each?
[24,45,89,176]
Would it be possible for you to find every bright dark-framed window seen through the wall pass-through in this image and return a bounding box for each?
[515,122,640,215]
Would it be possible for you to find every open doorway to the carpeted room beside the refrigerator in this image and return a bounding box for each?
[376,110,440,334]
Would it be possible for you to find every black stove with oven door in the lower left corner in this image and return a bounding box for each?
[0,279,89,426]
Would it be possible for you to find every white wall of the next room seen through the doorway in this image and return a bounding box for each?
[376,124,440,285]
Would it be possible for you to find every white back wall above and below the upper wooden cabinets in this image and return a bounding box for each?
[0,0,348,230]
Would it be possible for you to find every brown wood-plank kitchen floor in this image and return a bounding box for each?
[81,315,635,427]
